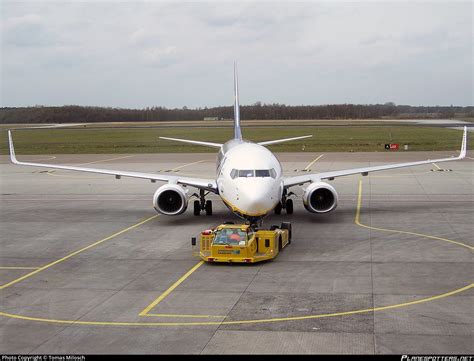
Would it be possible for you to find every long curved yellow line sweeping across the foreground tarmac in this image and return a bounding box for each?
[0,283,474,327]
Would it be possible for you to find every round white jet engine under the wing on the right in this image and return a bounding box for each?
[303,182,338,213]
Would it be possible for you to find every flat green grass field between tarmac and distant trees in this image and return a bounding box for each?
[0,125,466,155]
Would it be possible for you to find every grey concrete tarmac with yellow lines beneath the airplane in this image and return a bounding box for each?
[0,152,474,354]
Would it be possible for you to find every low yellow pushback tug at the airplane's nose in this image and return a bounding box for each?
[191,222,291,263]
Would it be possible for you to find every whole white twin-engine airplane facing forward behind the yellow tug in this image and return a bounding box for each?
[8,66,467,223]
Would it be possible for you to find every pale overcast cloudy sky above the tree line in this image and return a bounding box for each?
[0,0,474,108]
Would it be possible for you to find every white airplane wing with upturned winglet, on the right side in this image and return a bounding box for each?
[283,127,467,188]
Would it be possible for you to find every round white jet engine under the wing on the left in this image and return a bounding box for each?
[153,184,188,216]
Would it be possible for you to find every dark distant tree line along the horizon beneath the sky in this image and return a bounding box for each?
[0,102,474,124]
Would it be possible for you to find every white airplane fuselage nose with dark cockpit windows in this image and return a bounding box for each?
[216,139,283,219]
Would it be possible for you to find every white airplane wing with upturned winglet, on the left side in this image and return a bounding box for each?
[8,130,217,193]
